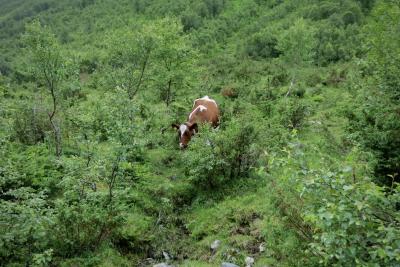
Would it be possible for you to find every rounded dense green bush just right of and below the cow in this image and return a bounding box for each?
[184,120,260,189]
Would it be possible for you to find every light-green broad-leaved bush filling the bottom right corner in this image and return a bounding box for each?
[303,172,400,266]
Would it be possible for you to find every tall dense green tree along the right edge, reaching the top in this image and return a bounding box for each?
[348,1,400,185]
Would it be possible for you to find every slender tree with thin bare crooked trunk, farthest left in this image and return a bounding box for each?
[24,20,67,157]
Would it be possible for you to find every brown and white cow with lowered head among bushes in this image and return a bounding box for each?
[172,96,219,148]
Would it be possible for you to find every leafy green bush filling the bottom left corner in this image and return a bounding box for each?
[0,186,54,266]
